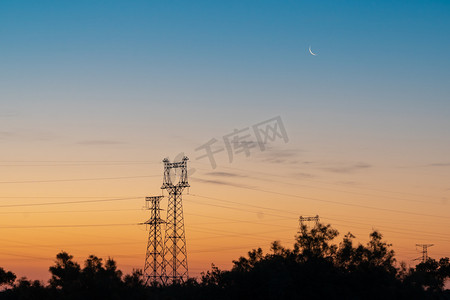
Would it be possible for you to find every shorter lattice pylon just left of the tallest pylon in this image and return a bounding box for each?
[144,196,164,285]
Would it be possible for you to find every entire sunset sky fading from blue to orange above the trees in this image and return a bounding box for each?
[0,0,450,281]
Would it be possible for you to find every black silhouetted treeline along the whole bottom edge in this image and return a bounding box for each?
[0,223,450,299]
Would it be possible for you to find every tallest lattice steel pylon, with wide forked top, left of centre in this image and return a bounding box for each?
[161,156,189,284]
